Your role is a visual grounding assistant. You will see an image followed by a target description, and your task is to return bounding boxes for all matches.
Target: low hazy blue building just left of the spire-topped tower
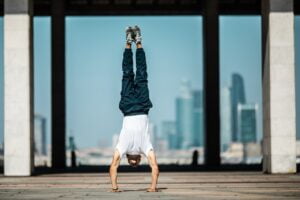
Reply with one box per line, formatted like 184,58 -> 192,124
161,121 -> 178,149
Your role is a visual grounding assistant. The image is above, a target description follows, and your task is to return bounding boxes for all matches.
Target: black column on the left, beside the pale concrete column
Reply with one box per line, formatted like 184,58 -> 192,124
51,0 -> 66,169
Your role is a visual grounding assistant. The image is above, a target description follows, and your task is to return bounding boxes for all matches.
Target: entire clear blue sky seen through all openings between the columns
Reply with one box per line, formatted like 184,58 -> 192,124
0,16 -> 300,147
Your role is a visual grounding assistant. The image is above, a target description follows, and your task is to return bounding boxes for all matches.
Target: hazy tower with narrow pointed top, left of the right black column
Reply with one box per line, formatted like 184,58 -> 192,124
176,80 -> 193,149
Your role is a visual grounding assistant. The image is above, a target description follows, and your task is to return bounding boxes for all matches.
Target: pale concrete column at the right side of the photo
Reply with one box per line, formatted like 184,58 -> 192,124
262,0 -> 296,173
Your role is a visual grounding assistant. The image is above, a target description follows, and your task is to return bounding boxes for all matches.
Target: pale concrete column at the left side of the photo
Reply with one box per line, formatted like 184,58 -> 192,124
4,0 -> 34,176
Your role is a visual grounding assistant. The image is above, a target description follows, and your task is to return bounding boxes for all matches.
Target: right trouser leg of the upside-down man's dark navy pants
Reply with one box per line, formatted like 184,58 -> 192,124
135,43 -> 152,109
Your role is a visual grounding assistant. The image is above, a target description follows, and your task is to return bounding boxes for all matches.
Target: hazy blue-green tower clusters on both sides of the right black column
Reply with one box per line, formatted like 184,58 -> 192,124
160,73 -> 262,152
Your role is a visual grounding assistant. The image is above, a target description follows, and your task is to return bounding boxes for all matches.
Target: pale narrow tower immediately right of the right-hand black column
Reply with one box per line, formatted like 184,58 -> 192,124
220,87 -> 232,152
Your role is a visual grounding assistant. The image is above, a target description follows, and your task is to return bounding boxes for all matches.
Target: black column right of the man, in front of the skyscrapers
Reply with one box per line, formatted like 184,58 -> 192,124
203,0 -> 220,168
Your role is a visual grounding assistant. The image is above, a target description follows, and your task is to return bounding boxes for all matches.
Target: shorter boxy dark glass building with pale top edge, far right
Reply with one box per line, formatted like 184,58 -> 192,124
238,104 -> 258,143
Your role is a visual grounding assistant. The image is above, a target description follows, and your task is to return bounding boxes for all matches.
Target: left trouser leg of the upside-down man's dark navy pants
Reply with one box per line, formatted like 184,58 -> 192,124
119,44 -> 134,111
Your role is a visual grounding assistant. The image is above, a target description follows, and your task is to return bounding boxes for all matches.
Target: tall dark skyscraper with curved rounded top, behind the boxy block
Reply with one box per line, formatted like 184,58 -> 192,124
231,73 -> 246,142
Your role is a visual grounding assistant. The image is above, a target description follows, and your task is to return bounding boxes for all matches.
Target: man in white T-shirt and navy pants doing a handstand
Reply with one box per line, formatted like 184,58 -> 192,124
109,26 -> 159,192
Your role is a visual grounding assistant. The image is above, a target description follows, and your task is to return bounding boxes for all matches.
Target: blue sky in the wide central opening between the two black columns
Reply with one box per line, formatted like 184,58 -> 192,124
66,17 -> 202,148
